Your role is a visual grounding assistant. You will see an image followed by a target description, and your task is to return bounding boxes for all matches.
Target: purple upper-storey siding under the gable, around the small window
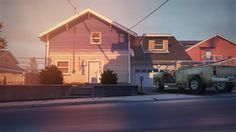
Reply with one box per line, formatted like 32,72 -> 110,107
49,15 -> 128,52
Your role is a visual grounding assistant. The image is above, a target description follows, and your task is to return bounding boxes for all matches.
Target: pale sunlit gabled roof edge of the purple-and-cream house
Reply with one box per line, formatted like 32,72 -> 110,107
39,8 -> 137,38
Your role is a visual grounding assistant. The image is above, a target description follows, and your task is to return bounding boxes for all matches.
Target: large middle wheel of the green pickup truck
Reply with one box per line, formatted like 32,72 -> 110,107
189,77 -> 205,94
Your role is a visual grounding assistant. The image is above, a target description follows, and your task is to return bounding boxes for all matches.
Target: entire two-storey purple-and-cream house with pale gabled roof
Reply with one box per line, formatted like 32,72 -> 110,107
39,9 -> 136,83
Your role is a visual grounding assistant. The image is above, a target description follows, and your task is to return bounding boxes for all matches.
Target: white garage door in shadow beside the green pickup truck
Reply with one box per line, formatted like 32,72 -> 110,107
135,69 -> 158,87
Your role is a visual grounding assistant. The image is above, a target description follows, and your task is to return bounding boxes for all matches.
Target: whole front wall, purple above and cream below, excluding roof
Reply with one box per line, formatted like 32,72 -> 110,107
48,14 -> 129,83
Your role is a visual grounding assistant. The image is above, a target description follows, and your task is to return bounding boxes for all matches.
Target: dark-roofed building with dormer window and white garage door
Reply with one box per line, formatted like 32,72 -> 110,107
131,34 -> 191,87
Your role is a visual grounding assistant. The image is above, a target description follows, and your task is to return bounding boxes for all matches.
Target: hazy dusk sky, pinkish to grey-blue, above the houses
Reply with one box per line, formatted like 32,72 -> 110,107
0,0 -> 236,57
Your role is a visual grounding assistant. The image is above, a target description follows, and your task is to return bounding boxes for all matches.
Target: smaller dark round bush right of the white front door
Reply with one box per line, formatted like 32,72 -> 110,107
100,69 -> 118,84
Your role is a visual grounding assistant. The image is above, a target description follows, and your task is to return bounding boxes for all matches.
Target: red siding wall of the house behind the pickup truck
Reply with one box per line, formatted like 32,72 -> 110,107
186,36 -> 236,61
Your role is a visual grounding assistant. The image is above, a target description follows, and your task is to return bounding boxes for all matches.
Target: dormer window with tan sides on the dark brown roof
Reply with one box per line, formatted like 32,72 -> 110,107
148,39 -> 168,53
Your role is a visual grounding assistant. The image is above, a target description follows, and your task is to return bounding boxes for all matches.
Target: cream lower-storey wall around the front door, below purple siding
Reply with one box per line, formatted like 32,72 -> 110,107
50,52 -> 128,83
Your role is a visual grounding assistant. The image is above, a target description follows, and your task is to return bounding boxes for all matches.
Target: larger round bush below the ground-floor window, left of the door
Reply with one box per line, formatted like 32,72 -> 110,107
39,65 -> 63,84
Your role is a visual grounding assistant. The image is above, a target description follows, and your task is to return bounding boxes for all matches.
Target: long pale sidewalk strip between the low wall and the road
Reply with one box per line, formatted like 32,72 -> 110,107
0,93 -> 236,109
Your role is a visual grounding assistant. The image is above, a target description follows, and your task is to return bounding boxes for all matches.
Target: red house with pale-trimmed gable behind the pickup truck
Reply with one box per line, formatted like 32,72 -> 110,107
186,34 -> 236,63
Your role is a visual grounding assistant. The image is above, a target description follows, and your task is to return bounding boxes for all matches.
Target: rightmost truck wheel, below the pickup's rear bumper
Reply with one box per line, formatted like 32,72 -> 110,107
214,82 -> 233,93
